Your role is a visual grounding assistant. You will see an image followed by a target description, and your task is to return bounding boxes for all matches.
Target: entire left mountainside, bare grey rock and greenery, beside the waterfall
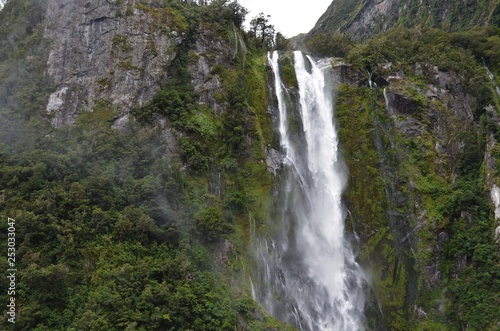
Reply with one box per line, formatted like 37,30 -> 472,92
0,0 -> 291,331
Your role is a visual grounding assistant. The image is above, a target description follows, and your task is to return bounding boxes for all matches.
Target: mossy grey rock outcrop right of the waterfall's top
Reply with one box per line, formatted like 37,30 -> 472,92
332,60 -> 473,169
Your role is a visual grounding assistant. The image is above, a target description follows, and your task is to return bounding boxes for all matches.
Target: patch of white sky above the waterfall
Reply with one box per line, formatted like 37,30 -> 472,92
238,0 -> 332,38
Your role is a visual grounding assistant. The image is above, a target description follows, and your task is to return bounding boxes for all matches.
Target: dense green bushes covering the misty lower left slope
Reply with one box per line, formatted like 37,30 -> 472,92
0,98 -> 284,330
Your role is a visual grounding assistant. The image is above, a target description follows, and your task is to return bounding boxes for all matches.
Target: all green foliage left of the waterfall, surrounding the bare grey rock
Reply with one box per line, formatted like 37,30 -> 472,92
0,1 -> 290,330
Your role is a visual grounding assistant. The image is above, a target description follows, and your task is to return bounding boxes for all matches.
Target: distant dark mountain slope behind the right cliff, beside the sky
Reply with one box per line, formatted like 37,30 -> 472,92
308,0 -> 500,39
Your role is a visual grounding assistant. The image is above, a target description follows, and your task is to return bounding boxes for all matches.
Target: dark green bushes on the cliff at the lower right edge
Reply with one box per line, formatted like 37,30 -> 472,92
432,123 -> 500,330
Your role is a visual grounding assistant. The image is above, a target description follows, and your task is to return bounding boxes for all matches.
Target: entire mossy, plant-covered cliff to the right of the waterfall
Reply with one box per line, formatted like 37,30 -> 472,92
316,24 -> 500,330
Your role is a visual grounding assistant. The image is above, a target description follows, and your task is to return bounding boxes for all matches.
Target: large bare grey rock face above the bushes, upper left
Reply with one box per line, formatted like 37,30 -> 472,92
45,0 -> 182,127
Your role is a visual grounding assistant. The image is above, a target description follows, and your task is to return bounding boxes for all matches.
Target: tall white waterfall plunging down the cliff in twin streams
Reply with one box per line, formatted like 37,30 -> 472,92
256,51 -> 365,331
